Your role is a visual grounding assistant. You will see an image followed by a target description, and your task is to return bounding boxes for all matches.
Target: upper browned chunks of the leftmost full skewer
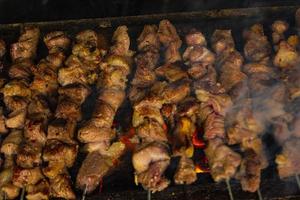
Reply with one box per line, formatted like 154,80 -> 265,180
2,27 -> 40,128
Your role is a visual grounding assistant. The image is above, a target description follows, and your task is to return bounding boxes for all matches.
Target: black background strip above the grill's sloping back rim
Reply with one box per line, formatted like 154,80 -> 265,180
0,0 -> 300,23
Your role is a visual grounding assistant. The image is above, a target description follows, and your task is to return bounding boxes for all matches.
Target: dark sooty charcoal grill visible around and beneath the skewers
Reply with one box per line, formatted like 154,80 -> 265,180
0,6 -> 300,200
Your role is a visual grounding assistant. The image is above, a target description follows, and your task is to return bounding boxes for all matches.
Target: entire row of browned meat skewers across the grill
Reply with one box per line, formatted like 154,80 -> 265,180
0,8 -> 300,199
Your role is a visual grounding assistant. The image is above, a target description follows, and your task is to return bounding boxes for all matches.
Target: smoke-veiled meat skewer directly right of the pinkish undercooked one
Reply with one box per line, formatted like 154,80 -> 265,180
212,27 -> 263,192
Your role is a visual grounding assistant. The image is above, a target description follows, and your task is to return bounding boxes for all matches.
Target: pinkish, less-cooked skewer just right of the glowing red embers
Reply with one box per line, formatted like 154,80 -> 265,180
189,28 -> 241,199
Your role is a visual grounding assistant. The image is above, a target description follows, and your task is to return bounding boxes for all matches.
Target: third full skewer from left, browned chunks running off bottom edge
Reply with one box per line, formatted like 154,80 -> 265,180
43,30 -> 101,199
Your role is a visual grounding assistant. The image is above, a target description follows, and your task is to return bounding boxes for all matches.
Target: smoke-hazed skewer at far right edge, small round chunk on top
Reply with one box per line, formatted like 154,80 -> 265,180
272,16 -> 300,189
